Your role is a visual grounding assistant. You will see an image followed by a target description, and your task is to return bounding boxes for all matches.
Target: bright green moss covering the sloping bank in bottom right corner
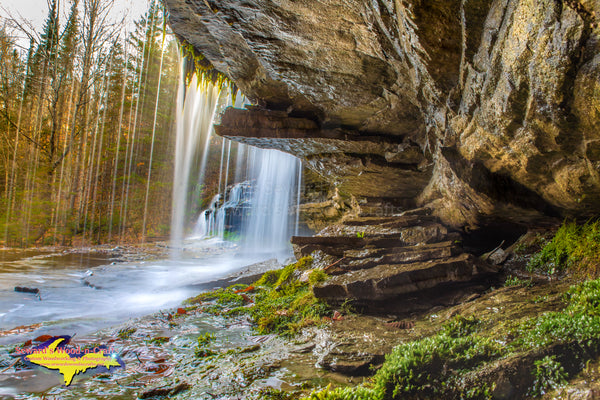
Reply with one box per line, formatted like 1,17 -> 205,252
308,280 -> 600,400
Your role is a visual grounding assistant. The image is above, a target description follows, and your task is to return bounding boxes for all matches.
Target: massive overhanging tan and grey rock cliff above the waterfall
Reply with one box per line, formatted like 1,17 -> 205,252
165,0 -> 600,226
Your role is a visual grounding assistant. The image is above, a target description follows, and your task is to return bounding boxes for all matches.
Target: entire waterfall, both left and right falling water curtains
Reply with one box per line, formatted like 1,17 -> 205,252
171,70 -> 302,258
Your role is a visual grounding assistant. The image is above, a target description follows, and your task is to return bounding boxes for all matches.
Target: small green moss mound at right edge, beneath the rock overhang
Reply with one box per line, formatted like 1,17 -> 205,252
527,221 -> 600,277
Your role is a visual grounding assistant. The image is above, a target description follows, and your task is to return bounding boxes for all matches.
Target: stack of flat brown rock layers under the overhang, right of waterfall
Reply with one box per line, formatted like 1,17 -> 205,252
292,209 -> 498,315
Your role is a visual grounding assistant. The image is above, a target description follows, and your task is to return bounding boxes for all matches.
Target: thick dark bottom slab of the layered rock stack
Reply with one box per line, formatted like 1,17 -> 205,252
313,254 -> 495,303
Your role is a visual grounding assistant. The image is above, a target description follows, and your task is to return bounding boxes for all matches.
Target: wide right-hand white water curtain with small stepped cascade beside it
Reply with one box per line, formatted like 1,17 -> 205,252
193,147 -> 302,259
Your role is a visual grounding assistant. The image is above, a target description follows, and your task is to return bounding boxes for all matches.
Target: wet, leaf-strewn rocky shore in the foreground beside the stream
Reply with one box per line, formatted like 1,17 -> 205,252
0,220 -> 600,399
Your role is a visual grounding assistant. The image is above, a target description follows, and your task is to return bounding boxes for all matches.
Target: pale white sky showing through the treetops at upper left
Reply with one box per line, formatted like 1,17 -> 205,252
0,0 -> 149,49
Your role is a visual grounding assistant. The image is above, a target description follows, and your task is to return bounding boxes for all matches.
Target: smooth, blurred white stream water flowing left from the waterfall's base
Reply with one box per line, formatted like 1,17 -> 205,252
0,247 -> 264,344
